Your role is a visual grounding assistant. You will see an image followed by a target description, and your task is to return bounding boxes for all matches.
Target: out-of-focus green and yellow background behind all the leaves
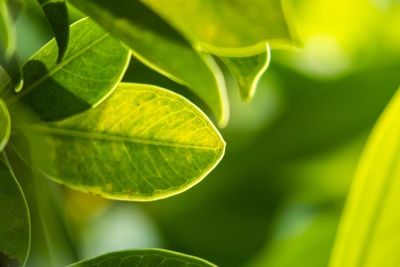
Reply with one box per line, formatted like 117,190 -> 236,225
17,0 -> 400,267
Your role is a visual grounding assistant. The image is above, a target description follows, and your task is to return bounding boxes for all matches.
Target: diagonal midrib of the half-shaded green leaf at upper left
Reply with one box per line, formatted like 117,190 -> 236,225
11,33 -> 109,100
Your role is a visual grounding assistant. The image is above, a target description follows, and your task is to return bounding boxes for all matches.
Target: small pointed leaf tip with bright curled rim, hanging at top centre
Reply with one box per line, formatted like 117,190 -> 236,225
221,43 -> 271,102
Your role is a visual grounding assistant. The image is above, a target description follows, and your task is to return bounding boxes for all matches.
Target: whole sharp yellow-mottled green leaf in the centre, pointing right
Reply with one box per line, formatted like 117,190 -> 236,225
13,83 -> 225,201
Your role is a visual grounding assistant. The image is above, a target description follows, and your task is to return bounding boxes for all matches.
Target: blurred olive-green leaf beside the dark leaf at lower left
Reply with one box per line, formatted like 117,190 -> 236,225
6,147 -> 77,267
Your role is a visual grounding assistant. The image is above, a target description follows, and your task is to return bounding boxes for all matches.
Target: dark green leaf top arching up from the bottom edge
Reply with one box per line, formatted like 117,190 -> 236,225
68,248 -> 216,267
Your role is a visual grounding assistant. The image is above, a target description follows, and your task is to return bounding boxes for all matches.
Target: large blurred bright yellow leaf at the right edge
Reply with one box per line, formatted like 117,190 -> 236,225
329,86 -> 400,267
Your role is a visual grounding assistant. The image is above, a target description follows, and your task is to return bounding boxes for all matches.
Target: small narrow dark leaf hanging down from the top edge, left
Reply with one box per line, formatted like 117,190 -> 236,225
38,0 -> 69,62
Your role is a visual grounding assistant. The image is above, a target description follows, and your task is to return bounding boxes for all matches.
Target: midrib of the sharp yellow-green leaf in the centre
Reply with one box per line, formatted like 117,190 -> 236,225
20,125 -> 223,150
